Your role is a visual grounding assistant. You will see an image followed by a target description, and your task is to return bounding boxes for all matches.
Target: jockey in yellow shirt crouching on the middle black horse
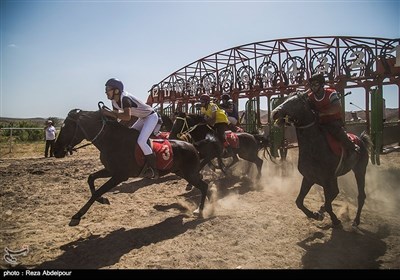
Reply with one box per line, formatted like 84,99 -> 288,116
200,94 -> 229,149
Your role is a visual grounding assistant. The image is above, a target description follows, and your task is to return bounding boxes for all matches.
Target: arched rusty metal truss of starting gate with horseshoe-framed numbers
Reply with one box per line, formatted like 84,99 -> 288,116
147,36 -> 400,125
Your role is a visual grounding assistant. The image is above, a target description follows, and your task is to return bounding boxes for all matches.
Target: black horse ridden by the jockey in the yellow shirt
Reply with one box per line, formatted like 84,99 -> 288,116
169,112 -> 263,179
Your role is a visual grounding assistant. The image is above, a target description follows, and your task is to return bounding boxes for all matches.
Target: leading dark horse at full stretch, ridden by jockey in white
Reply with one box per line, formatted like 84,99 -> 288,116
54,109 -> 208,226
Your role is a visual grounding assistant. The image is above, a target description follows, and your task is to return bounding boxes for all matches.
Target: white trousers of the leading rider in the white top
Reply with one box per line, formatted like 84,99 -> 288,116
131,113 -> 158,156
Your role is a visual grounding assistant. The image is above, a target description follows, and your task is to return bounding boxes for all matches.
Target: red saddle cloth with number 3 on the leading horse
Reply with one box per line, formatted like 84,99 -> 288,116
135,139 -> 174,170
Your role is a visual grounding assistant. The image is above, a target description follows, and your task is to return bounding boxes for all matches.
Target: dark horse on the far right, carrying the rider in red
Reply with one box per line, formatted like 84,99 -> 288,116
272,92 -> 372,226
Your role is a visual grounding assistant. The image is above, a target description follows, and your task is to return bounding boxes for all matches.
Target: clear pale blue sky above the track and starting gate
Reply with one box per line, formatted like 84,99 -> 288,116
0,0 -> 400,118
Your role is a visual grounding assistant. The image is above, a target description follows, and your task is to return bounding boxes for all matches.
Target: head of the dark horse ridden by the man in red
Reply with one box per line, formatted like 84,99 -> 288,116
272,92 -> 315,127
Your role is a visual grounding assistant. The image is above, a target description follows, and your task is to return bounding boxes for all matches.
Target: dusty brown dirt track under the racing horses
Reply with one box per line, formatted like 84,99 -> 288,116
0,147 -> 400,269
